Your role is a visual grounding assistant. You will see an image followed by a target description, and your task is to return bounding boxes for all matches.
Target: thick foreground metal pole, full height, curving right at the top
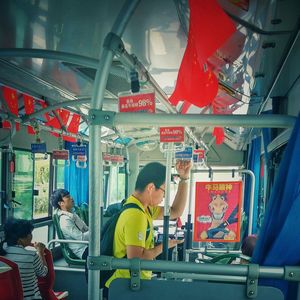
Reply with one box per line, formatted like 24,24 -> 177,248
88,0 -> 139,300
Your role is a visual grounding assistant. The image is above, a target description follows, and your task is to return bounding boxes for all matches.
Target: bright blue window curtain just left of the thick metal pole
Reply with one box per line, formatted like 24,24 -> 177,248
64,142 -> 89,206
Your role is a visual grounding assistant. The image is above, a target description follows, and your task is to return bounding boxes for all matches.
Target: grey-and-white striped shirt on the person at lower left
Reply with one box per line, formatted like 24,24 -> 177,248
4,245 -> 48,300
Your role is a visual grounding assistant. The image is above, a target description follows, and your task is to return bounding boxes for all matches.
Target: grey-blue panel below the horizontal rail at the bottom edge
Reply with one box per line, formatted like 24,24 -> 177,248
109,279 -> 284,300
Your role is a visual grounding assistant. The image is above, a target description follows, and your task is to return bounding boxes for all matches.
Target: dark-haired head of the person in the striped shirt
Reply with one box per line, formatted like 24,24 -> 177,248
4,219 -> 33,247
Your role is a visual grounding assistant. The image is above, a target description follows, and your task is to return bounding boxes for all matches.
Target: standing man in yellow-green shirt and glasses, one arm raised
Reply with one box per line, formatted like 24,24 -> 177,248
105,161 -> 192,288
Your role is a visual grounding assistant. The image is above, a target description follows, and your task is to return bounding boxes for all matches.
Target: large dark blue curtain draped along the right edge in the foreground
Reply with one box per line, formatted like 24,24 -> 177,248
253,115 -> 300,299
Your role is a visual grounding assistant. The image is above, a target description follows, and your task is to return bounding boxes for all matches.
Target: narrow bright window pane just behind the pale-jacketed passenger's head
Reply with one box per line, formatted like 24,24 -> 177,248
33,154 -> 50,219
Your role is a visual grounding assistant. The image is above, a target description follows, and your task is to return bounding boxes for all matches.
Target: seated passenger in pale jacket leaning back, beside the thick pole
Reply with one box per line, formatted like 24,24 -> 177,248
50,189 -> 89,259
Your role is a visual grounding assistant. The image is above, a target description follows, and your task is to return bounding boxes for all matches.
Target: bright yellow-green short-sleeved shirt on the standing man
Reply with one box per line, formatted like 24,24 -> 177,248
105,196 -> 160,287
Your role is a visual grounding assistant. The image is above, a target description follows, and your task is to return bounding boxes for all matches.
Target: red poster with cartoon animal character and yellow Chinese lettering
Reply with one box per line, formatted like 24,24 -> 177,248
194,181 -> 242,242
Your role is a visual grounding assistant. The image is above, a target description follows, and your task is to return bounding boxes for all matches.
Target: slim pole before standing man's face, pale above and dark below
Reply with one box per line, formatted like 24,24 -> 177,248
163,143 -> 173,260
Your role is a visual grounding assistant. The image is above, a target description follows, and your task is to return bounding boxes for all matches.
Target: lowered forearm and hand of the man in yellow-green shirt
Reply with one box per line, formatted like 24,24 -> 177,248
126,240 -> 184,260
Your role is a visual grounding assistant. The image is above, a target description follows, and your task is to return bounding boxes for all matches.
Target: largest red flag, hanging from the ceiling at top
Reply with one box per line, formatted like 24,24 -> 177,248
170,0 -> 235,107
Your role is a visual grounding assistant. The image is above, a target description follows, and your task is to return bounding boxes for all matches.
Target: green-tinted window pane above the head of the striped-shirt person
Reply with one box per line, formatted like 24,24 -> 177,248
13,150 -> 33,220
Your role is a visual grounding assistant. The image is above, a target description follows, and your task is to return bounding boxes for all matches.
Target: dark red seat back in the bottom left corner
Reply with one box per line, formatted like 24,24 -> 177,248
0,256 -> 23,300
